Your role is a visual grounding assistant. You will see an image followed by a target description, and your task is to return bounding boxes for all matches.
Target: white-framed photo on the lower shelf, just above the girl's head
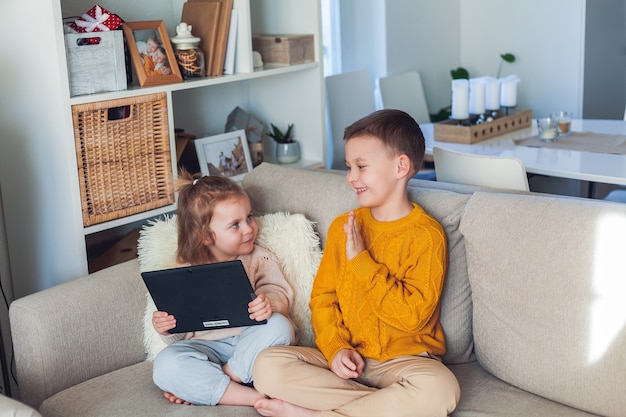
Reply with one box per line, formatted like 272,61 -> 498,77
194,129 -> 252,181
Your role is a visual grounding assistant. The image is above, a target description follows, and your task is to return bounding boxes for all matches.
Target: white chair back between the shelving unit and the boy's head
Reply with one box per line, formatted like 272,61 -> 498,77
325,70 -> 376,169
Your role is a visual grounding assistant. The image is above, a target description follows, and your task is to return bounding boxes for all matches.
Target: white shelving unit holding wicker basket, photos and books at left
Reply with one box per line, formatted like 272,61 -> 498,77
0,0 -> 326,298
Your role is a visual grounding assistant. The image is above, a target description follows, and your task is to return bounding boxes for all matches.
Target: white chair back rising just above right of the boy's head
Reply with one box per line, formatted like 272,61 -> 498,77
378,71 -> 430,124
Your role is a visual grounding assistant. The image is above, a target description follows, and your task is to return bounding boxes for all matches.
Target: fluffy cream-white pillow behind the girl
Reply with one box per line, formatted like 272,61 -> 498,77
137,213 -> 322,360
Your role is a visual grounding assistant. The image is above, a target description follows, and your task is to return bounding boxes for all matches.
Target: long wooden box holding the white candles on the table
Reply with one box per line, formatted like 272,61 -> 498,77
434,110 -> 533,144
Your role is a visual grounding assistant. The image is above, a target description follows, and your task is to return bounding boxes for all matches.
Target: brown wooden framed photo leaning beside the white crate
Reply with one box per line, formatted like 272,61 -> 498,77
122,20 -> 183,87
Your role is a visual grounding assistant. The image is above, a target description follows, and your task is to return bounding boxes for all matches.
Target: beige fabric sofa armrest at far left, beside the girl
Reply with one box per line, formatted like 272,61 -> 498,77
9,260 -> 147,408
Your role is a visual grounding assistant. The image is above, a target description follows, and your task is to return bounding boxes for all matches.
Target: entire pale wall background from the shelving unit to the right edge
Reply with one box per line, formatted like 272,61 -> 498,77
341,0 -> 626,122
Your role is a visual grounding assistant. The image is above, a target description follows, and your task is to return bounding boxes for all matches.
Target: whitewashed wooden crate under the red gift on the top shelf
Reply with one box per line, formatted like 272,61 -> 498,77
65,30 -> 127,96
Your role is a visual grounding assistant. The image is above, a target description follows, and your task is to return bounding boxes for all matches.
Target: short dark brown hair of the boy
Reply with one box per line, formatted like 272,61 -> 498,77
343,109 -> 426,176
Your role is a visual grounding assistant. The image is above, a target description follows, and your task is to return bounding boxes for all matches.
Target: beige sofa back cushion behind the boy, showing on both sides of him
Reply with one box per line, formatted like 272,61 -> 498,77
243,163 -> 474,363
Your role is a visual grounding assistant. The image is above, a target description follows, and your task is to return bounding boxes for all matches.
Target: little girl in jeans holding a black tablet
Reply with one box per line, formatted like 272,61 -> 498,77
152,171 -> 295,406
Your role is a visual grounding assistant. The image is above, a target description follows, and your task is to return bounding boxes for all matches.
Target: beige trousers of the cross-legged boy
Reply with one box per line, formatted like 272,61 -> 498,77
252,346 -> 460,417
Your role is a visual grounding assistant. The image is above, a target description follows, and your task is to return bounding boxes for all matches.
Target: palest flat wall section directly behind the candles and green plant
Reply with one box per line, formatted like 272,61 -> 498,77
460,0 -> 585,117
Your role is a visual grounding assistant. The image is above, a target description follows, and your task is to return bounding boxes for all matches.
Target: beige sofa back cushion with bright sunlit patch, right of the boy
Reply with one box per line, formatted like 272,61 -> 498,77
461,192 -> 626,416
